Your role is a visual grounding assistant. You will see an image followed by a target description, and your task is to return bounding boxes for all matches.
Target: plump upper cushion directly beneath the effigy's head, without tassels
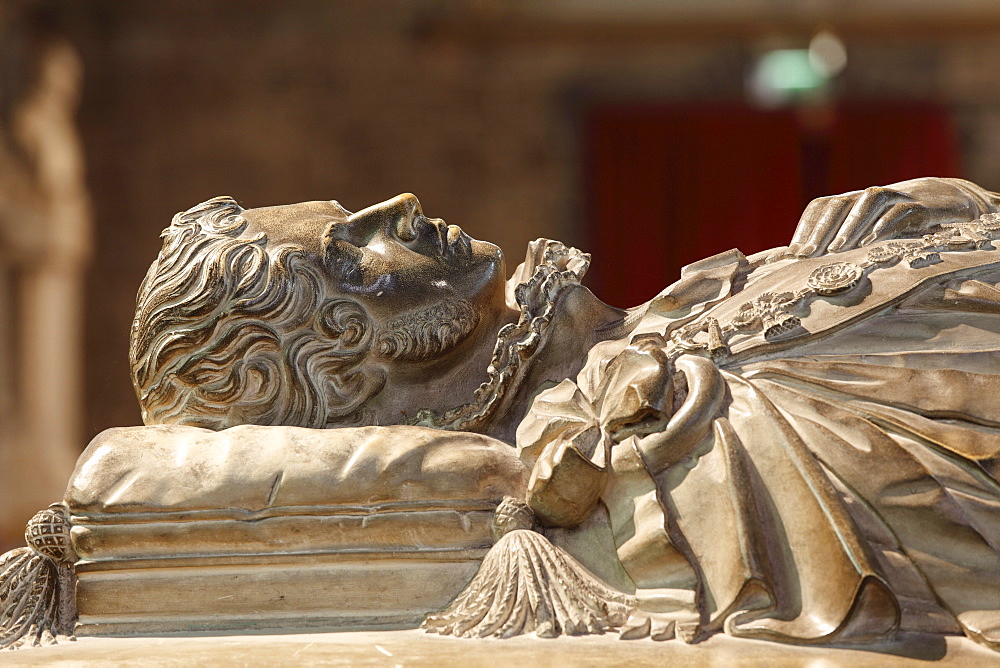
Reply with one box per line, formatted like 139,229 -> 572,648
66,426 -> 528,561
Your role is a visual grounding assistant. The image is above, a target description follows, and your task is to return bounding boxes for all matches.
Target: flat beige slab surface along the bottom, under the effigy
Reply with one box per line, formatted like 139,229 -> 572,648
0,630 -> 1000,668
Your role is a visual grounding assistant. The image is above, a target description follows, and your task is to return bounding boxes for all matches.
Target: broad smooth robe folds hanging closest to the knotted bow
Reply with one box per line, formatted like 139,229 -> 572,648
625,362 -> 900,643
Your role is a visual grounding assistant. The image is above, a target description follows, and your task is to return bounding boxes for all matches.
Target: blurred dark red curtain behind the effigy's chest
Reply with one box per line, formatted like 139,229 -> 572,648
584,102 -> 959,306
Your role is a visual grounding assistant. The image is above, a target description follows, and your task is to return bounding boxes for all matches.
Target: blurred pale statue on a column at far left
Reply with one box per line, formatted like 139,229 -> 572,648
0,14 -> 91,545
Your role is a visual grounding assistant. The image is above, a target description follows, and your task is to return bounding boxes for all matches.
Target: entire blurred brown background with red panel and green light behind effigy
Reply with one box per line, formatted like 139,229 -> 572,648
0,0 -> 1000,547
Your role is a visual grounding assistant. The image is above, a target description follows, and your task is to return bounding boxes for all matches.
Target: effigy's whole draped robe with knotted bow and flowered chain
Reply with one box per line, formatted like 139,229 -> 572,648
518,238 -> 1000,645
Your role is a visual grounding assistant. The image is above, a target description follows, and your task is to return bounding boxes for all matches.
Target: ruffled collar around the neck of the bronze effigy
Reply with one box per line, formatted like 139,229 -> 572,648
412,239 -> 590,431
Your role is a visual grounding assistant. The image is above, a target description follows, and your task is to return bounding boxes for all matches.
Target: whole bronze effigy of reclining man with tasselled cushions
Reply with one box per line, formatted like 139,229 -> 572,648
0,179 -> 1000,649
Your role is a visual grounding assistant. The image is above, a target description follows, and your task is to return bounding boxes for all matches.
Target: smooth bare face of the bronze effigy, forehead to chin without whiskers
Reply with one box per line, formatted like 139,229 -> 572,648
243,194 -> 505,322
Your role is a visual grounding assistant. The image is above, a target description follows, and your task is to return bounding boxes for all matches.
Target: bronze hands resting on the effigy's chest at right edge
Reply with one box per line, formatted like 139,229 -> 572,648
780,177 -> 1000,257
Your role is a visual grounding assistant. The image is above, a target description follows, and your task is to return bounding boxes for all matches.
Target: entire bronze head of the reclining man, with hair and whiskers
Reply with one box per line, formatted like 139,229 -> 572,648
129,195 -> 519,429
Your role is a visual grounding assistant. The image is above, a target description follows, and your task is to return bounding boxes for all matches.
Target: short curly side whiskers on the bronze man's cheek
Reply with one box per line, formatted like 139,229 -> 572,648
377,299 -> 479,361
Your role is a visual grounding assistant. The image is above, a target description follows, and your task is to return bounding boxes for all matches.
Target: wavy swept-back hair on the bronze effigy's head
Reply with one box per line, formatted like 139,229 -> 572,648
129,197 -> 385,429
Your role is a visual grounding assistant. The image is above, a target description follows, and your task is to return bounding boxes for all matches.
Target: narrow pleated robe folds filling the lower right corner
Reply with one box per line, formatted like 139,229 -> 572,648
746,361 -> 1000,645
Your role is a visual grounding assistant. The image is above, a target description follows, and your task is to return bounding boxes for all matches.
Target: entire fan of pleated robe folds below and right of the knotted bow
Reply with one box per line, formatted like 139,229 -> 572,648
605,344 -> 1000,644
